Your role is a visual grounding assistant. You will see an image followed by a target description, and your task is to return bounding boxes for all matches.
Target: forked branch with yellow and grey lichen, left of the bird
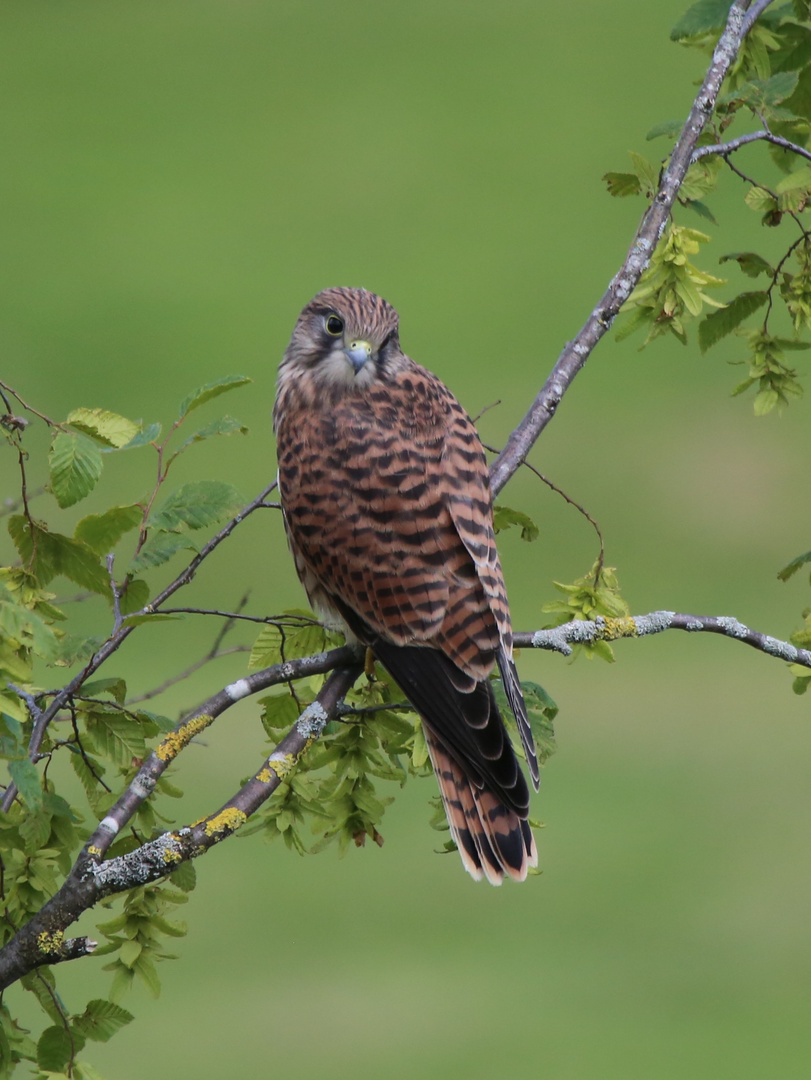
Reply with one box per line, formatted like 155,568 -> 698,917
0,646 -> 363,990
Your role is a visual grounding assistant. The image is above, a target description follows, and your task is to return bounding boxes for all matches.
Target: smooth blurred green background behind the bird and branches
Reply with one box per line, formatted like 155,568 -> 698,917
0,0 -> 811,1080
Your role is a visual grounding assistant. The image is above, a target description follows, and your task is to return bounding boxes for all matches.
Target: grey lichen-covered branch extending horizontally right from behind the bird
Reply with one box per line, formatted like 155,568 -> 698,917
513,611 -> 811,667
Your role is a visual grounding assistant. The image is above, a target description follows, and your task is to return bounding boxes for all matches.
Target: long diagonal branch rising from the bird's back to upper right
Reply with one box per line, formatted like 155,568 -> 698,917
490,0 -> 771,494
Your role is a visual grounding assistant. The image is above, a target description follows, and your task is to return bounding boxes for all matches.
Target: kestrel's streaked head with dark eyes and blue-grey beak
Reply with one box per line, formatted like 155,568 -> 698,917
279,287 -> 403,394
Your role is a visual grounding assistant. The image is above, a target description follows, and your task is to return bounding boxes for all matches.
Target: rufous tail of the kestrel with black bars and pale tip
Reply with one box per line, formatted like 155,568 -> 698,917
422,719 -> 538,885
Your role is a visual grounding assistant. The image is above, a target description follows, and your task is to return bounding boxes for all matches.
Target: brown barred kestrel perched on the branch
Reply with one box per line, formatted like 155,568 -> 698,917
273,286 -> 540,885
